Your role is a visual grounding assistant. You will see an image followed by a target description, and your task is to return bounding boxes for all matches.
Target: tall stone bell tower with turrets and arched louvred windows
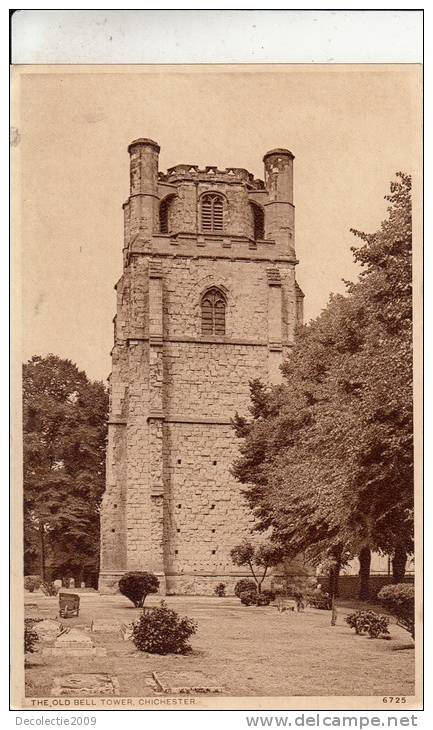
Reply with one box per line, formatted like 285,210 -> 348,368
99,139 -> 303,593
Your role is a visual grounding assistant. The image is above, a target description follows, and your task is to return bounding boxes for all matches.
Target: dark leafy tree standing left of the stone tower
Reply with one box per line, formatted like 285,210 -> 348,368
23,355 -> 108,580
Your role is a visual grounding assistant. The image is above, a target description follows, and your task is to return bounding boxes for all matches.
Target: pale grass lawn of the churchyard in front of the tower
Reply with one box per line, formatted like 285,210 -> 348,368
26,593 -> 415,697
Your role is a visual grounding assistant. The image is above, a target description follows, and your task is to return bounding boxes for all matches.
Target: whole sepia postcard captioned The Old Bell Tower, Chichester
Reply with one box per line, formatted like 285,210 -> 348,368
11,22 -> 423,711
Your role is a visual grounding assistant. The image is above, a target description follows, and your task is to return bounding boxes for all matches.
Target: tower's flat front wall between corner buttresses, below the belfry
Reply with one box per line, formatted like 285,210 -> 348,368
158,258 -> 295,593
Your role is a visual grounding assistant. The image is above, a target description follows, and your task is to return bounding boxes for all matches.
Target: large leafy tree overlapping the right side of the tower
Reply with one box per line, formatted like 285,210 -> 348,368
233,173 -> 413,598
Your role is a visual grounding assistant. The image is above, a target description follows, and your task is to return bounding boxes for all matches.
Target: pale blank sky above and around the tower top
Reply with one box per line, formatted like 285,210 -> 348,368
15,65 -> 421,380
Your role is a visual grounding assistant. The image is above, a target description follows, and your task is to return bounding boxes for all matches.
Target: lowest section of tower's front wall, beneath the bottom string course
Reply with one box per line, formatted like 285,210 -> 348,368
165,423 -> 252,593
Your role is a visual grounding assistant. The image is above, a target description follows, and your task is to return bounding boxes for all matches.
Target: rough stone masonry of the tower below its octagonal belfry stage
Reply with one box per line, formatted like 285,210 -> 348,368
102,256 -> 296,593
